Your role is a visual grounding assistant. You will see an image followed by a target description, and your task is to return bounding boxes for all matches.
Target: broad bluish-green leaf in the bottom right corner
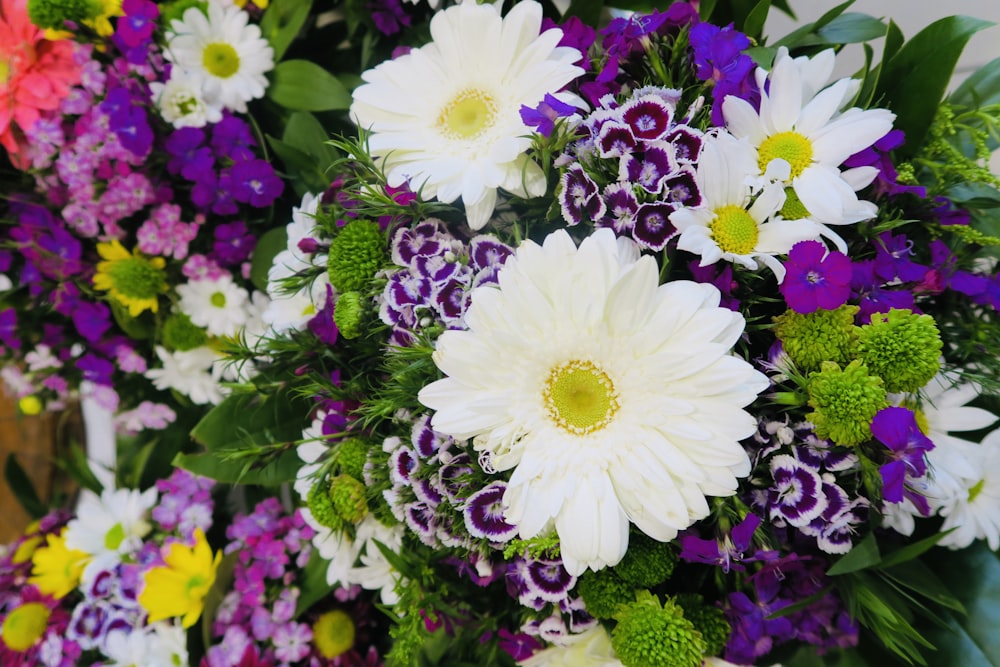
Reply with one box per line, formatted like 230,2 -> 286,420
927,542 -> 1000,667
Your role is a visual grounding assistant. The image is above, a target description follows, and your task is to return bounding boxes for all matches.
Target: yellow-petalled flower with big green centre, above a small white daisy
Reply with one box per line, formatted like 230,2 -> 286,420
94,239 -> 167,317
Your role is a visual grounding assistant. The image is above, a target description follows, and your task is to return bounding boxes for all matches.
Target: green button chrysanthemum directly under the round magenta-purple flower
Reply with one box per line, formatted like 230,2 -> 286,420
774,305 -> 859,372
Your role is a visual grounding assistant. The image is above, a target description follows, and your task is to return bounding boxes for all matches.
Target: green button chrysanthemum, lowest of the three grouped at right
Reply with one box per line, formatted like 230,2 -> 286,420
806,359 -> 889,446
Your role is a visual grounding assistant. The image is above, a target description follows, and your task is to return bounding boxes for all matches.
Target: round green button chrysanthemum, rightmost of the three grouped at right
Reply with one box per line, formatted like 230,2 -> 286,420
858,308 -> 942,392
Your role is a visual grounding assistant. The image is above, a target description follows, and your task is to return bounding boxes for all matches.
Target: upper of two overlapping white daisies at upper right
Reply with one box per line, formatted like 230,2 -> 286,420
722,47 -> 895,240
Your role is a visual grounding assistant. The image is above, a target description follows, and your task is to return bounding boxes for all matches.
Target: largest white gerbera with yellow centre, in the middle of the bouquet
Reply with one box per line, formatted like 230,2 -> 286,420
419,229 -> 768,575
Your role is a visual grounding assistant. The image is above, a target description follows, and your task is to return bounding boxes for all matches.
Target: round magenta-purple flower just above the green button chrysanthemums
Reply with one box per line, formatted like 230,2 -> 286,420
778,241 -> 852,314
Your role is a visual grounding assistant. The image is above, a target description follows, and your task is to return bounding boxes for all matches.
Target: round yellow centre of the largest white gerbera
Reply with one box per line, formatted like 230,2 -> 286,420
542,361 -> 619,435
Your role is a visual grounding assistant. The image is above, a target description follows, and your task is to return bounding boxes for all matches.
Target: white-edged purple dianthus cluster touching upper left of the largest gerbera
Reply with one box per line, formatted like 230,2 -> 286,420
379,220 -> 513,346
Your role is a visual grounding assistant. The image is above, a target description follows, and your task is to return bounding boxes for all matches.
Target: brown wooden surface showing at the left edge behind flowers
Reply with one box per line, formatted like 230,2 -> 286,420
0,392 -> 76,544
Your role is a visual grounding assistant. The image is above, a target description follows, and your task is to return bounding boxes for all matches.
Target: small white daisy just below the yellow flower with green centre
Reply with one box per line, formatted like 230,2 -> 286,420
177,275 -> 250,336
